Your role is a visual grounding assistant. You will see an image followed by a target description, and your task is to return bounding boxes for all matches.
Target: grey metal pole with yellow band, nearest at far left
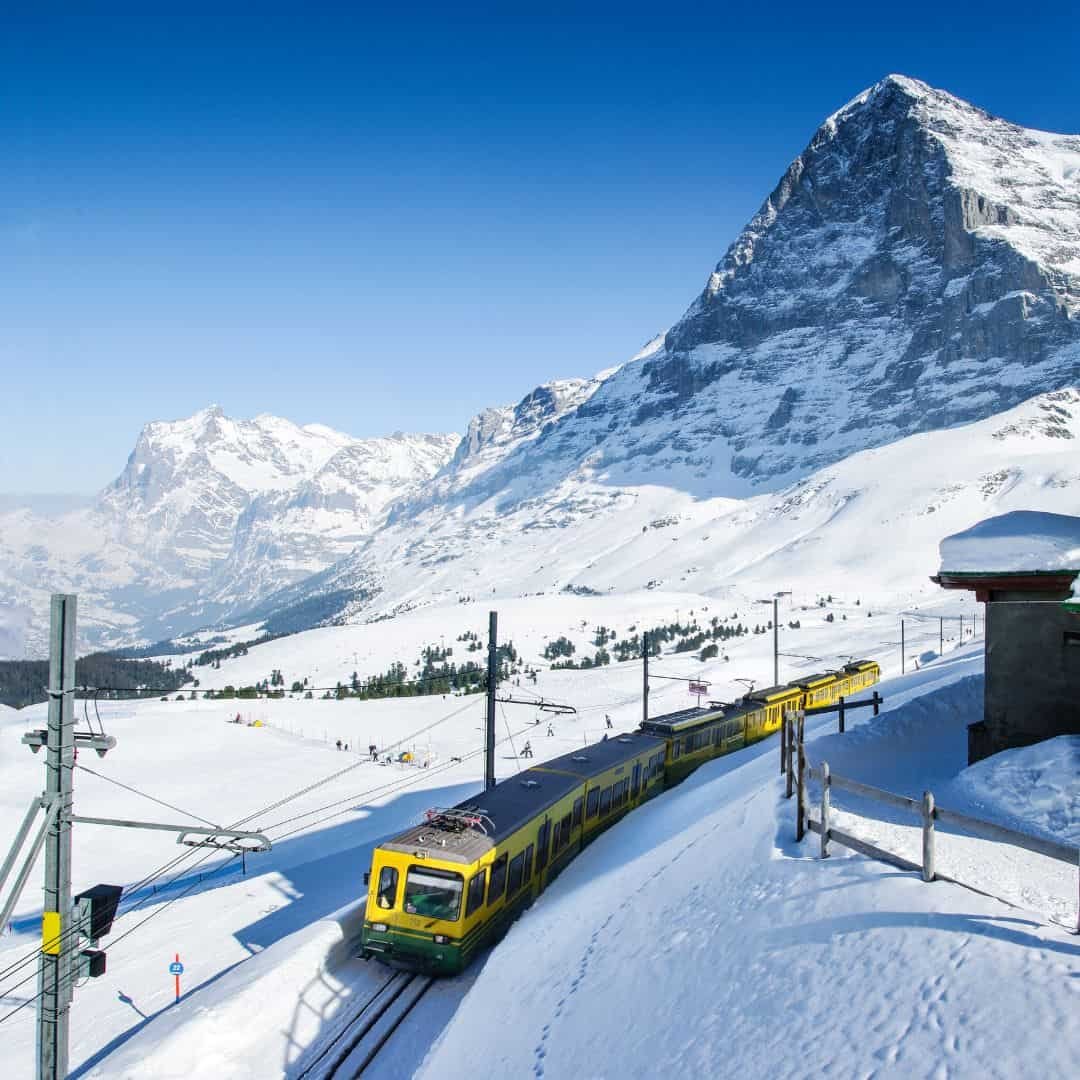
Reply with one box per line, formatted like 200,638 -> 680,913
38,594 -> 77,1080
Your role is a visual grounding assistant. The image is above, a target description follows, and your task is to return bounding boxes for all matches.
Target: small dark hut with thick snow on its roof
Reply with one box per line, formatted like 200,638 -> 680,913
931,511 -> 1080,764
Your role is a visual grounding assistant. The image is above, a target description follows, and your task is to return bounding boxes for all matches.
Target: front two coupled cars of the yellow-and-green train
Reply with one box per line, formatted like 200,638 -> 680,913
361,731 -> 664,974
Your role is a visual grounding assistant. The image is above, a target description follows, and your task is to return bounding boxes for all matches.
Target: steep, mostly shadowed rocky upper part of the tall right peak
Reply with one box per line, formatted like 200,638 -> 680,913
609,76 -> 1080,485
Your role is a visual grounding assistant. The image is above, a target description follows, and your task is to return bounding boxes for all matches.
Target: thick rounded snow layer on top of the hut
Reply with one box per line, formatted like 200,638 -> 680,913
940,510 -> 1080,576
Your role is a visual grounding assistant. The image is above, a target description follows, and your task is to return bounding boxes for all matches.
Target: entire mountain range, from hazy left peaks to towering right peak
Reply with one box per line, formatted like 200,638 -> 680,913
0,76 -> 1080,652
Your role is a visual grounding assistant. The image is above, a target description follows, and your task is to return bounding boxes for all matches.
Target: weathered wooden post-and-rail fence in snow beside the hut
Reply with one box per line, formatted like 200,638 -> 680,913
781,711 -> 1080,934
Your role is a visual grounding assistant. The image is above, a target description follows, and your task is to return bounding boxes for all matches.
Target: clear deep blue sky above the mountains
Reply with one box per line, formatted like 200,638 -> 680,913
6,2 -> 1080,492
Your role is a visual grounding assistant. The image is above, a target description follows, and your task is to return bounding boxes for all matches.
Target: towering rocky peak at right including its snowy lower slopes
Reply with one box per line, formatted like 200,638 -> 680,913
254,76 -> 1080,630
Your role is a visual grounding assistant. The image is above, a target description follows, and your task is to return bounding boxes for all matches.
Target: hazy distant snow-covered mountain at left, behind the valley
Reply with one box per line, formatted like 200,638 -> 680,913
0,406 -> 460,656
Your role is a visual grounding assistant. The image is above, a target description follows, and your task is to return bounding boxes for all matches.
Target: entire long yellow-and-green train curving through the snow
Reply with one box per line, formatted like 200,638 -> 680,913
361,660 -> 880,974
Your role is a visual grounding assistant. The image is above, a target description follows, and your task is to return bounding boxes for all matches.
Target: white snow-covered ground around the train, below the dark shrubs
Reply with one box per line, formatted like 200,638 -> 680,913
0,622 -> 1080,1078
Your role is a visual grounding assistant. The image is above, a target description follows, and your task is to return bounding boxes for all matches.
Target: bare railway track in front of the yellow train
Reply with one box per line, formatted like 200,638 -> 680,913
297,971 -> 434,1080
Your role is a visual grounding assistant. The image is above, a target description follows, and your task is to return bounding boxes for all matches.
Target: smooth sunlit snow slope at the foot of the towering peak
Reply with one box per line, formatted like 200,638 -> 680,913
267,389 -> 1080,620
